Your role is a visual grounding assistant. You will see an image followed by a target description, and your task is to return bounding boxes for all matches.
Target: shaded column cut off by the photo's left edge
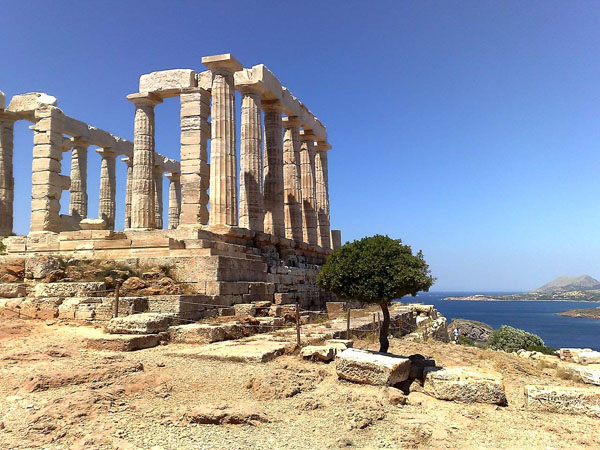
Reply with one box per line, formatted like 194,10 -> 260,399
0,111 -> 16,236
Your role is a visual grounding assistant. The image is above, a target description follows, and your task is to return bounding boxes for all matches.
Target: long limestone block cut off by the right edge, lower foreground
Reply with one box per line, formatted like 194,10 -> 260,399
525,385 -> 600,418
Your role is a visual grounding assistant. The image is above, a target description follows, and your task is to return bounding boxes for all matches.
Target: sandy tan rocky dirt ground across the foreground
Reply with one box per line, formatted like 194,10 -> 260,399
0,319 -> 600,449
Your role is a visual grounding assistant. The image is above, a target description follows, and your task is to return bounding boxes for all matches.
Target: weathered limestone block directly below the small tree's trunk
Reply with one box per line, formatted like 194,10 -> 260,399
335,348 -> 410,386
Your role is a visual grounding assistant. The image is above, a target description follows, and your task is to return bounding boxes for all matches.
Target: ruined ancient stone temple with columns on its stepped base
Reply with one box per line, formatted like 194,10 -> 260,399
0,54 -> 341,307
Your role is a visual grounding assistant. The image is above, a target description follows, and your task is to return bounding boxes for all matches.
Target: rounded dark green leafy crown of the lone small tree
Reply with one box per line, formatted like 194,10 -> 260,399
317,235 -> 435,303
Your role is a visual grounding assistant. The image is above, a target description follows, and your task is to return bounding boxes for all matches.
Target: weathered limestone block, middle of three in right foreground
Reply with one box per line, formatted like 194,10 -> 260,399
423,367 -> 506,405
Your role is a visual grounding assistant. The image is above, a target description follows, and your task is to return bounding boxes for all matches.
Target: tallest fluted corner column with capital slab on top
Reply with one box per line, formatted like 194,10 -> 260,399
202,54 -> 242,226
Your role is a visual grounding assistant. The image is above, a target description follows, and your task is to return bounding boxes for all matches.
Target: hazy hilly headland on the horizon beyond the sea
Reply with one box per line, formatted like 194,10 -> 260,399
444,275 -> 600,300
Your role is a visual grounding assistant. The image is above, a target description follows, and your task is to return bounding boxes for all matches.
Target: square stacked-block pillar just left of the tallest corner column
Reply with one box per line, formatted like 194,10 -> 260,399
179,88 -> 210,228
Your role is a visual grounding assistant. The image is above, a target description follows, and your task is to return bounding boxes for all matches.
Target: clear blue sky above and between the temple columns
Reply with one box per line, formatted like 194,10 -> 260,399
0,0 -> 600,290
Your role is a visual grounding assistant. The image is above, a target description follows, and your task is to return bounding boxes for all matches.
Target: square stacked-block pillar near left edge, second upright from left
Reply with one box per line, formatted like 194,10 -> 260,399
30,105 -> 70,233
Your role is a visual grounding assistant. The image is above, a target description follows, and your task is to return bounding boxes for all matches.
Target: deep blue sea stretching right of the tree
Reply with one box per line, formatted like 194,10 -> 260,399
400,292 -> 600,351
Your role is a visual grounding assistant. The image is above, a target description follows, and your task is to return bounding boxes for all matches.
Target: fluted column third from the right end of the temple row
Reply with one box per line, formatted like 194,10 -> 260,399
283,116 -> 302,242
